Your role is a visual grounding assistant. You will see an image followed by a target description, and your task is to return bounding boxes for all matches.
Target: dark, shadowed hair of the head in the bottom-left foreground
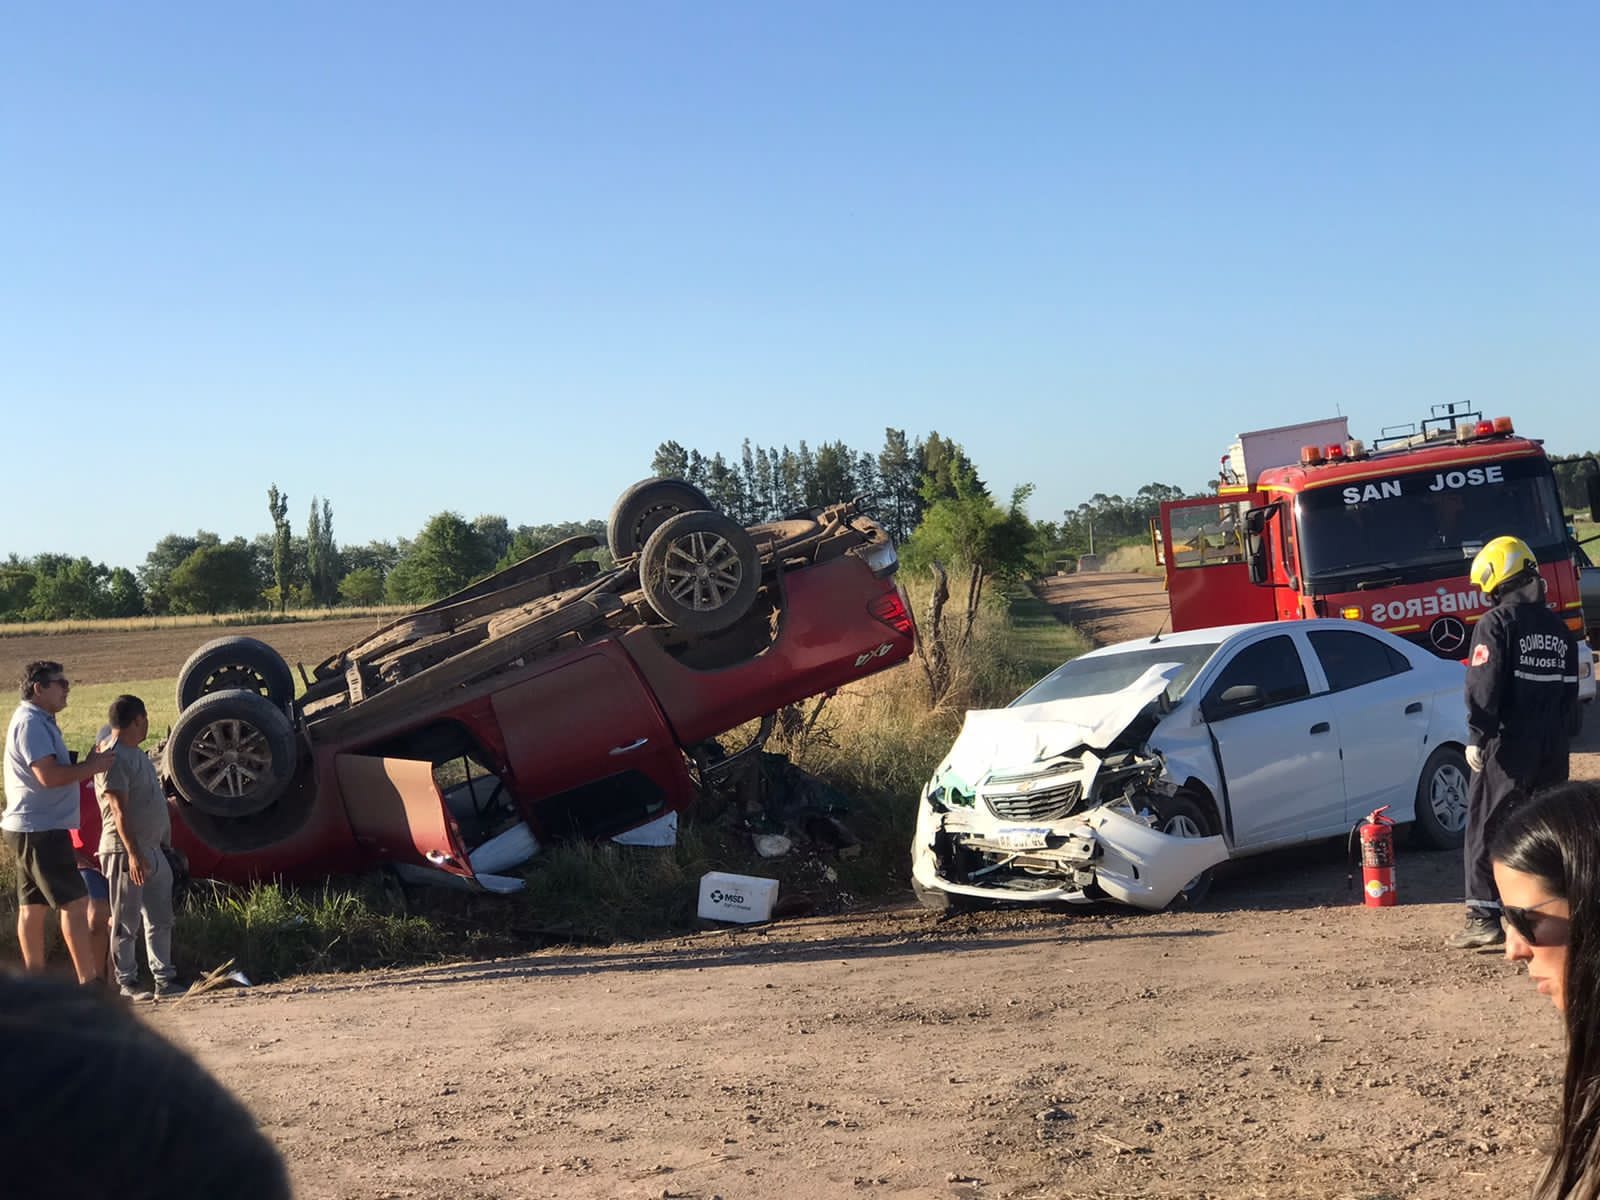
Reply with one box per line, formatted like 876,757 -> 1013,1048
0,973 -> 291,1200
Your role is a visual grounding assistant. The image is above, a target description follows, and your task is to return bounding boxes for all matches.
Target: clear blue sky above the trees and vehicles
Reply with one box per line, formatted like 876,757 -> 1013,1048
0,0 -> 1600,566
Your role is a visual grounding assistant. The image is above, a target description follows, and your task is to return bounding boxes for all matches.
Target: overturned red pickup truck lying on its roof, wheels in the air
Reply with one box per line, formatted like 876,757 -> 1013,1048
162,480 -> 915,882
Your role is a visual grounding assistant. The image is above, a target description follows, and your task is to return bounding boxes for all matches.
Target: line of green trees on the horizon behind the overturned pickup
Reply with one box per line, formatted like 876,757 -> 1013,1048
0,429 -> 1203,622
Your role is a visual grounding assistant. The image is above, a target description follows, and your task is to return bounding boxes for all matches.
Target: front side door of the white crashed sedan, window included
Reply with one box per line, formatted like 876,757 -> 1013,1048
1200,634 -> 1344,850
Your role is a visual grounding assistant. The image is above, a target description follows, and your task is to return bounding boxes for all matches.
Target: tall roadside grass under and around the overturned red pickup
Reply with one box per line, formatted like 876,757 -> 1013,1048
0,579 -> 1090,979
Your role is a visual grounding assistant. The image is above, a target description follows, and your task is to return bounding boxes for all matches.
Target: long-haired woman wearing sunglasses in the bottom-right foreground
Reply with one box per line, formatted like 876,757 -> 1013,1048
1490,782 -> 1600,1200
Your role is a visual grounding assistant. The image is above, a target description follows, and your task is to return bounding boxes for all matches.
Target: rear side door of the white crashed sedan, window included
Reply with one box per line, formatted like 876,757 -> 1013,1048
1306,629 -> 1434,826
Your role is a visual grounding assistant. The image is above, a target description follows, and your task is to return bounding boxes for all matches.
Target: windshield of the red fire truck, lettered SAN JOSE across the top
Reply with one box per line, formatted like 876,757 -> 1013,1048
1294,456 -> 1566,592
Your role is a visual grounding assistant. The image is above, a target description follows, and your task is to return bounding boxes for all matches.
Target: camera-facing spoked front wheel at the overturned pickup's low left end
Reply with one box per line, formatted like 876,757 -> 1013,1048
165,691 -> 298,818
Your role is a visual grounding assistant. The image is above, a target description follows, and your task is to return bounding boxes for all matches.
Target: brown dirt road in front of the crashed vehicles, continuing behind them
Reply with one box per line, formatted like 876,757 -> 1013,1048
152,578 -> 1600,1200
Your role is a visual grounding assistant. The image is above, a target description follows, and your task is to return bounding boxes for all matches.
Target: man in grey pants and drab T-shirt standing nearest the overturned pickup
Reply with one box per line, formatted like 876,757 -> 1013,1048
94,696 -> 182,1000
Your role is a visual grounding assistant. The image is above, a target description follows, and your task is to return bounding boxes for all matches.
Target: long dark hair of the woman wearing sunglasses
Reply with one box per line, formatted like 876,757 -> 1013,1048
1490,782 -> 1600,1200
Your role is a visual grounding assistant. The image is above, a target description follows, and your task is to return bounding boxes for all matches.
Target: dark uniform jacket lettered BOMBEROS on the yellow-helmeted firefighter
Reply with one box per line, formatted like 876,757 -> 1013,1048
1467,586 -> 1578,790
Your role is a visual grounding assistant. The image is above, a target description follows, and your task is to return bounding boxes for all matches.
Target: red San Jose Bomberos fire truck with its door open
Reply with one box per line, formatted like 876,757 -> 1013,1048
1154,405 -> 1600,658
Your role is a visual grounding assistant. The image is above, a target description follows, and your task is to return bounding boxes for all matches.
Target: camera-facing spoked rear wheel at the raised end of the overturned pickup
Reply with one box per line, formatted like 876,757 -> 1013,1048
638,512 -> 762,634
